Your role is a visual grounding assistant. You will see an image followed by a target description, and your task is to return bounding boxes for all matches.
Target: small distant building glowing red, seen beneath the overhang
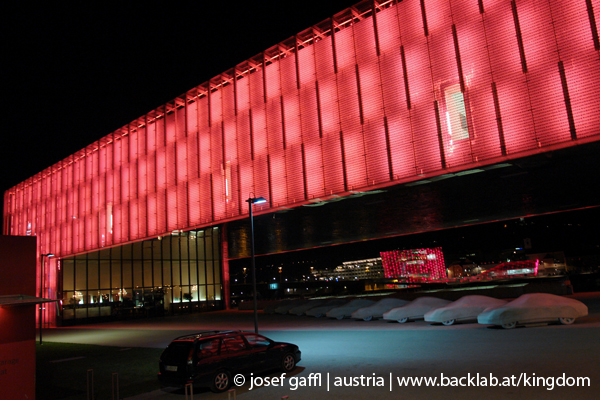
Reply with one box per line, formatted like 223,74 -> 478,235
381,247 -> 448,283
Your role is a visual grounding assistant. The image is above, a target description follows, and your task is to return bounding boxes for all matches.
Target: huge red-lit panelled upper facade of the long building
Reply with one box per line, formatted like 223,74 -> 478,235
4,0 -> 600,324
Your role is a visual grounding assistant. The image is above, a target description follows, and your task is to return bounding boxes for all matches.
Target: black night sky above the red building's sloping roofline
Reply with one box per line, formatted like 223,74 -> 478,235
0,0 -> 356,203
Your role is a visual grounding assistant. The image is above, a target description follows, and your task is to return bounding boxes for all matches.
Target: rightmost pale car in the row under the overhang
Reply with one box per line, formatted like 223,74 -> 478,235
477,293 -> 588,329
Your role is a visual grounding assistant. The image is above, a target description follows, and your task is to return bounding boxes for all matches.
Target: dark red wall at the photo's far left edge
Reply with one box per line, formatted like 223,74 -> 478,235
0,236 -> 36,400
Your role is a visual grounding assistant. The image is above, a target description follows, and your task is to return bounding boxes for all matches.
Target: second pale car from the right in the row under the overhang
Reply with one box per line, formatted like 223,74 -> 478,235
424,295 -> 507,325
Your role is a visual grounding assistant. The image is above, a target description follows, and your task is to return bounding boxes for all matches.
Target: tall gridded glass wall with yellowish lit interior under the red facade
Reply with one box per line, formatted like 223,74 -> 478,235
61,228 -> 221,321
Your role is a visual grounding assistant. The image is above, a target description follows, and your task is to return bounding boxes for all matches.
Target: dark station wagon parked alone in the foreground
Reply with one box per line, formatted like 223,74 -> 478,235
158,331 -> 301,393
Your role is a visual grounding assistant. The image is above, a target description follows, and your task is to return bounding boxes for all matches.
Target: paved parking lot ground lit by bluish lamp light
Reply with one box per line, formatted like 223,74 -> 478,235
44,293 -> 600,400
